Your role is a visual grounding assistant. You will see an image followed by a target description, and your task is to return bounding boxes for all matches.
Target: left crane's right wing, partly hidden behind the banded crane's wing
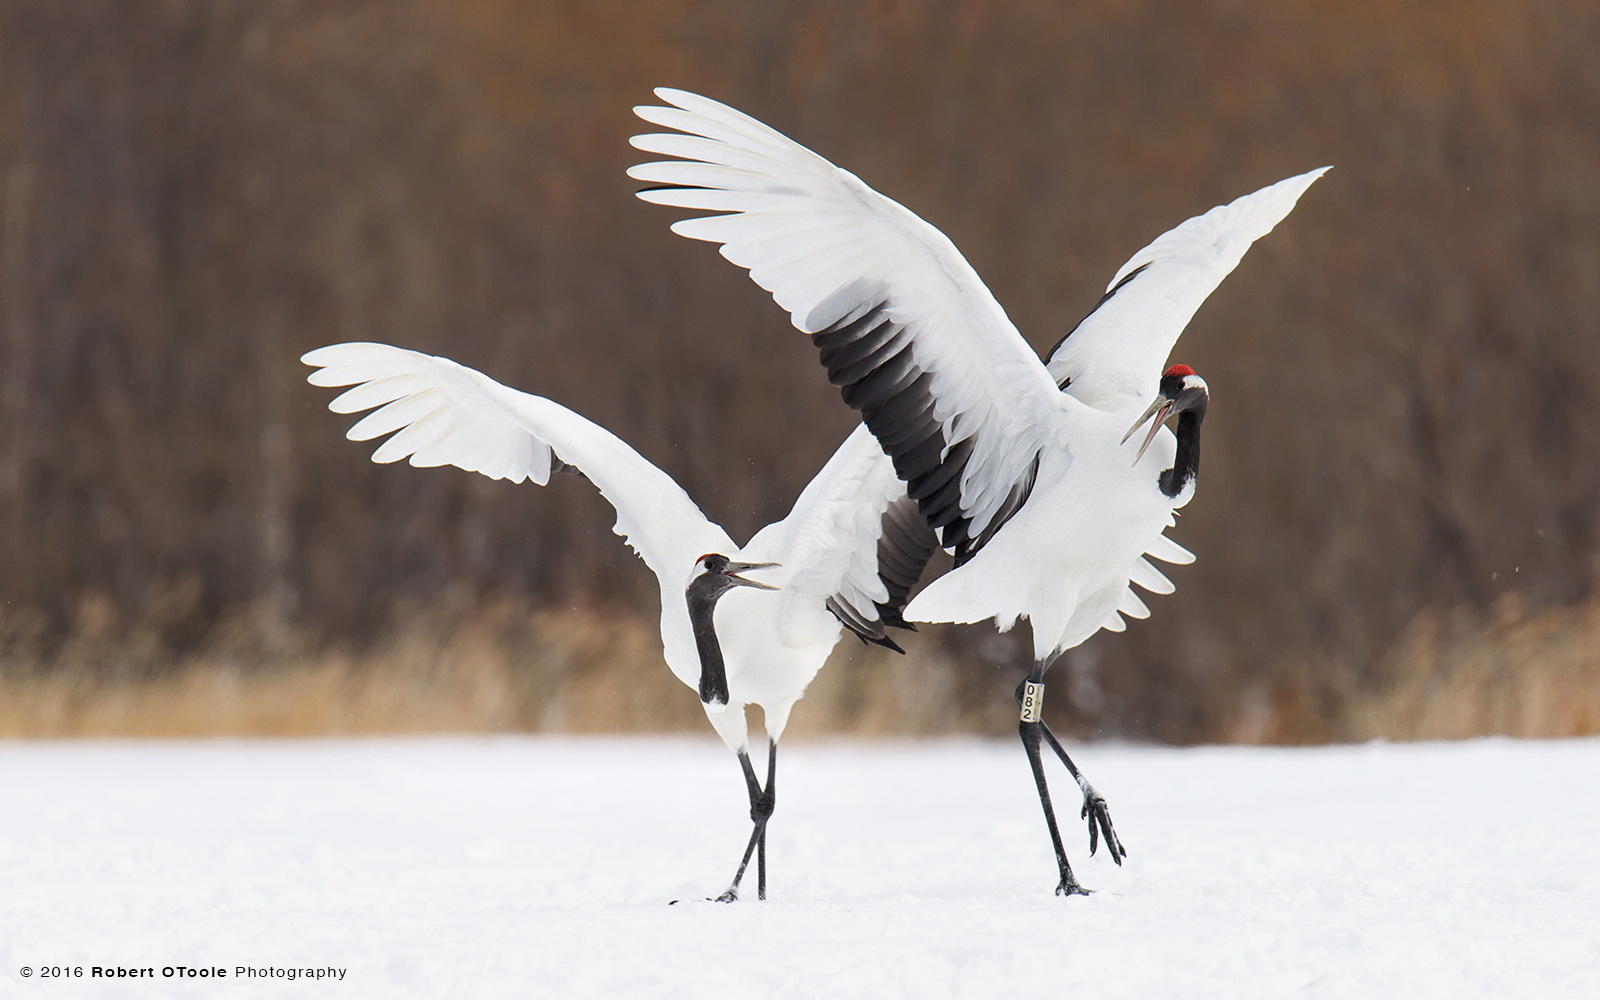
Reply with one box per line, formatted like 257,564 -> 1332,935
744,426 -> 938,651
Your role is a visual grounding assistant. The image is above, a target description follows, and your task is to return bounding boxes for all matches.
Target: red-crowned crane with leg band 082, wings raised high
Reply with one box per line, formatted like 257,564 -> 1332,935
627,88 -> 1326,894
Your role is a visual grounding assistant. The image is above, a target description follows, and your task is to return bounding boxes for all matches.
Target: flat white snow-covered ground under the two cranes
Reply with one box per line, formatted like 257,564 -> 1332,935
0,738 -> 1600,1000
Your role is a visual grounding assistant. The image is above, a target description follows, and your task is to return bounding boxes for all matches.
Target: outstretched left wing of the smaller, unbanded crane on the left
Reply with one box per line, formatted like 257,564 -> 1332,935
301,344 -> 736,584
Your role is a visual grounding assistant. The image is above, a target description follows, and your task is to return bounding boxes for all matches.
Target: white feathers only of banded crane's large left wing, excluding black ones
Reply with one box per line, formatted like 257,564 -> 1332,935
627,88 -> 1066,550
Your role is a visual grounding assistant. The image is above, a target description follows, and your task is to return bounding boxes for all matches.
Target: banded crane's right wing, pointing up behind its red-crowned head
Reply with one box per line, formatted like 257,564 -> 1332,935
1045,166 -> 1328,408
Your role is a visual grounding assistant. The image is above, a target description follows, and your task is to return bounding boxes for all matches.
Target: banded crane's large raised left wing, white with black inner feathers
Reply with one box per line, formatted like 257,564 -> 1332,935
627,88 -> 1075,563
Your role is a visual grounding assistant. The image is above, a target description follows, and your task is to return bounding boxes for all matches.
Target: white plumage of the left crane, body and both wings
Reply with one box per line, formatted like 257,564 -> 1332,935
301,344 -> 906,752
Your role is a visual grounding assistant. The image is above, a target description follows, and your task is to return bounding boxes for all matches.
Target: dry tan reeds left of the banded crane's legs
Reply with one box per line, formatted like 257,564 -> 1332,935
0,594 -> 1006,738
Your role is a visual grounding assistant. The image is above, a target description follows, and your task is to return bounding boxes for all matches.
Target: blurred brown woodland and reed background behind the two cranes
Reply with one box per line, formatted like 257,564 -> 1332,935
0,0 -> 1600,741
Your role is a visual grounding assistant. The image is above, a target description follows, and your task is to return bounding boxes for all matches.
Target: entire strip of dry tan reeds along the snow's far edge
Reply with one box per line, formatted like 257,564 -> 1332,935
0,592 -> 1600,744
